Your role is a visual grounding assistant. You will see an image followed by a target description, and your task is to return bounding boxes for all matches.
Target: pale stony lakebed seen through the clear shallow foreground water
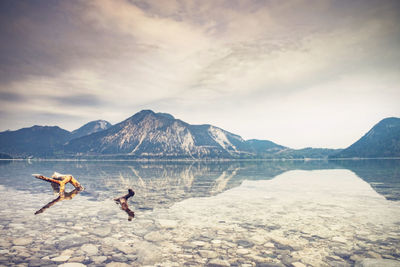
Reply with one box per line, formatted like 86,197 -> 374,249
0,170 -> 400,267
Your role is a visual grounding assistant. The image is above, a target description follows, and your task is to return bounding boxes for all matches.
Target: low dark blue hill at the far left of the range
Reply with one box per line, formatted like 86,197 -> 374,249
0,125 -> 70,157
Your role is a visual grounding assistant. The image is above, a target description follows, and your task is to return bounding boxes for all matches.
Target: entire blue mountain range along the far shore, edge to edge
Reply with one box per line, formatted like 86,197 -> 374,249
0,110 -> 400,159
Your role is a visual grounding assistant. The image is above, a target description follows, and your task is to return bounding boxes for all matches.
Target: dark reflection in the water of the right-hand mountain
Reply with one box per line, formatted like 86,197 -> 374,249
337,160 -> 400,200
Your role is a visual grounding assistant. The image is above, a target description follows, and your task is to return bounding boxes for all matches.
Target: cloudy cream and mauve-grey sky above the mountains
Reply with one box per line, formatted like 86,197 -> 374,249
0,0 -> 400,148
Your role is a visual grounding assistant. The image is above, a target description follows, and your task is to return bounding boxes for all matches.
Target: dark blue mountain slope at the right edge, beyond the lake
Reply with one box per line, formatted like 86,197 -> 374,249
332,117 -> 400,158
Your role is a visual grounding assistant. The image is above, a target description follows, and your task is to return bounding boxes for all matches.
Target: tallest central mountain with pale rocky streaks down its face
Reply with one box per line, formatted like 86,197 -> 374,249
64,110 -> 283,158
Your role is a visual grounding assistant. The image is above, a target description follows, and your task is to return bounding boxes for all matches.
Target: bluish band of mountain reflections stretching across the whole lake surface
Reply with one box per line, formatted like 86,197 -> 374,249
0,160 -> 400,209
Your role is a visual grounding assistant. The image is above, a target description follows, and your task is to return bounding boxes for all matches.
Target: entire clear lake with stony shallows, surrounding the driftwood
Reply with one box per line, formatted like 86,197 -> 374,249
0,160 -> 400,267
